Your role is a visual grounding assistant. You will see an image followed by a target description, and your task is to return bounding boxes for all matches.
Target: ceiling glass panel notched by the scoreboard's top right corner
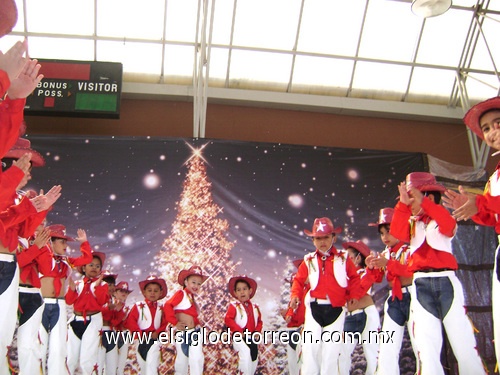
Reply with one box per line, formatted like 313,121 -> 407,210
97,41 -> 161,76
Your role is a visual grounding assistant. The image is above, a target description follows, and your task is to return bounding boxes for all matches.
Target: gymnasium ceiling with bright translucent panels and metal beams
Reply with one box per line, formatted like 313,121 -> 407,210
0,0 -> 500,126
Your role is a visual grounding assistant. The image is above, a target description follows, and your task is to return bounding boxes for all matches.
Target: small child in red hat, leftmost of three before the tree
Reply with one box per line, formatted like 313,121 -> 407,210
125,275 -> 167,375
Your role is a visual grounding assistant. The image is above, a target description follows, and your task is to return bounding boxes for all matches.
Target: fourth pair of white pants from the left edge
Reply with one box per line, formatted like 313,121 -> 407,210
67,313 -> 102,375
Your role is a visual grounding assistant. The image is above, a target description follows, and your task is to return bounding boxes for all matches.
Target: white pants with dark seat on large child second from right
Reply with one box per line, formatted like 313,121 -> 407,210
410,271 -> 485,375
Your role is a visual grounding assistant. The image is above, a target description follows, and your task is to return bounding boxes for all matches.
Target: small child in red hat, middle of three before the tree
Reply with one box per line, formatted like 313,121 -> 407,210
164,266 -> 208,375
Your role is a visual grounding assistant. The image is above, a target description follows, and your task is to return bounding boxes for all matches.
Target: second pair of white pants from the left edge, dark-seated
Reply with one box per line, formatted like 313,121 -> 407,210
17,286 -> 43,375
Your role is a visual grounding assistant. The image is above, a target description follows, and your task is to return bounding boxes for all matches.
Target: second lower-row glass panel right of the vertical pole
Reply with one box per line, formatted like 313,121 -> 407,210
229,50 -> 292,86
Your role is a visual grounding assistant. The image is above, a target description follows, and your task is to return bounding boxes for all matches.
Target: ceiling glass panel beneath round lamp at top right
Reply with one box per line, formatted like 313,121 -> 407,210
416,9 -> 472,66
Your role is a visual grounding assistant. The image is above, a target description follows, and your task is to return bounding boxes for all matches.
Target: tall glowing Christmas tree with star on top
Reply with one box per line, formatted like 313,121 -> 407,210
156,146 -> 237,374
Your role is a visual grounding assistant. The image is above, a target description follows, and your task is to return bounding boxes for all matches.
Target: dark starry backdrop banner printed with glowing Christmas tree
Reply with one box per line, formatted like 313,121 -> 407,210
21,136 -> 490,374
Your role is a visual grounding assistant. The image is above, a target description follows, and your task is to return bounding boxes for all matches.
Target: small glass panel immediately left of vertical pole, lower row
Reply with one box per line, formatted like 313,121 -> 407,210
164,45 -> 195,82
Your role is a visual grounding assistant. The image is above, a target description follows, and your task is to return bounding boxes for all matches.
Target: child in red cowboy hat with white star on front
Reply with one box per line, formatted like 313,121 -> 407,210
289,217 -> 366,375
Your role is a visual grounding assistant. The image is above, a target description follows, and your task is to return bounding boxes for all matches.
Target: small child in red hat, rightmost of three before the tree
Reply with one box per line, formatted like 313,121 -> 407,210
224,276 -> 262,375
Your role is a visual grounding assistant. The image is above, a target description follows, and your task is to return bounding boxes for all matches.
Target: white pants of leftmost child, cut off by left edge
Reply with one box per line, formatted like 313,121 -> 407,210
0,253 -> 19,375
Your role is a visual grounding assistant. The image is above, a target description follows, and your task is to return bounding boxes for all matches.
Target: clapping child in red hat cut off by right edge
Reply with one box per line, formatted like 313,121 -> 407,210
443,96 -> 500,368
